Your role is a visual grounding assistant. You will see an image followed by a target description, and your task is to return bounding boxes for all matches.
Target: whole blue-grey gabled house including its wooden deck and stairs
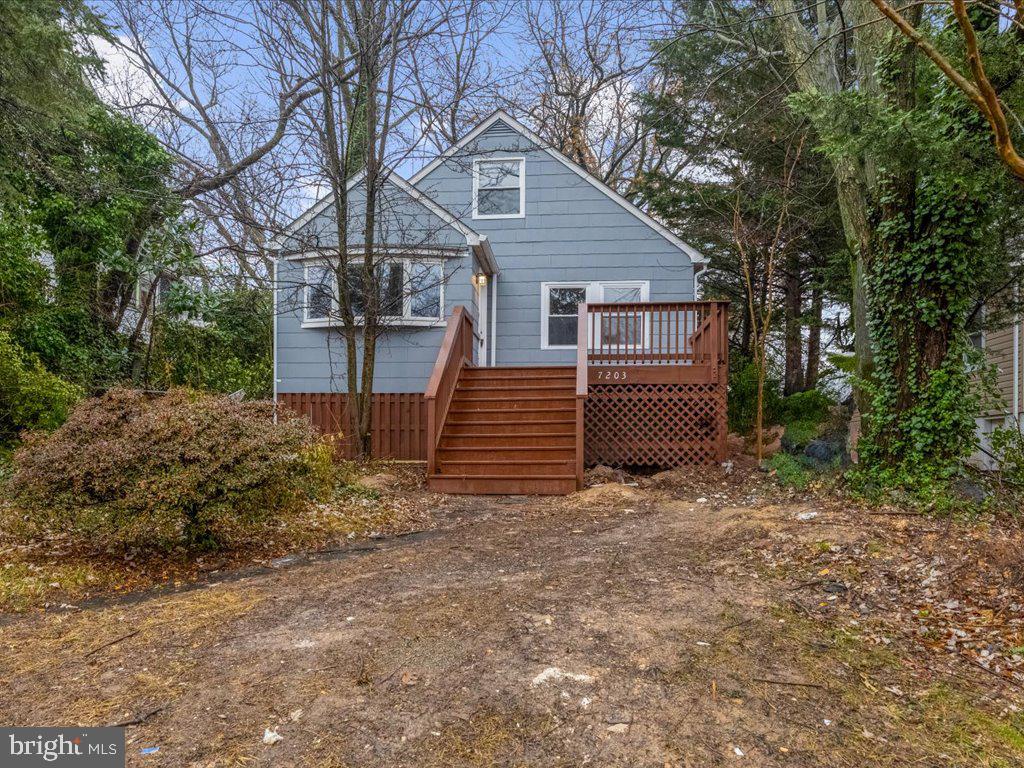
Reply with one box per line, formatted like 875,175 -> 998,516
274,111 -> 727,493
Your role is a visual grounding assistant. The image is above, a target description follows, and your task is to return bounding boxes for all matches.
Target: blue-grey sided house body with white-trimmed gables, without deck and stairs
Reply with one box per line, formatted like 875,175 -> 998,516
274,111 -> 720,493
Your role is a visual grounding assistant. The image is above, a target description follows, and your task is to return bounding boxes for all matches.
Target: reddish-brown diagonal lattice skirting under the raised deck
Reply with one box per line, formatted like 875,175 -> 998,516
584,383 -> 728,469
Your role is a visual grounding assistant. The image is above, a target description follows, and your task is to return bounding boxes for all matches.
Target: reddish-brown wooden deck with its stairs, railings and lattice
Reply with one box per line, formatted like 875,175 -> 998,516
424,301 -> 728,494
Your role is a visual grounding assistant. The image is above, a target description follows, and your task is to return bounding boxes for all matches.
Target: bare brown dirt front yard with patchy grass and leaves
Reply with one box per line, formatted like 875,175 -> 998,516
0,470 -> 1024,768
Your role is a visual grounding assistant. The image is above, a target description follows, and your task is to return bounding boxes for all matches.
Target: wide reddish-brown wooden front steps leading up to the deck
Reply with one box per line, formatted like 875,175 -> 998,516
428,366 -> 577,494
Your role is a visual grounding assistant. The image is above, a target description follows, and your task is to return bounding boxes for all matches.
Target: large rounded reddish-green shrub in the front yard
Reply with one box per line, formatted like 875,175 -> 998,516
8,389 -> 331,549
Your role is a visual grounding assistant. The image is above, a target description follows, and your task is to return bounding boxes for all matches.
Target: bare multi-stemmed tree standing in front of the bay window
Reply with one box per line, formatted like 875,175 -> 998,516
268,0 -> 483,455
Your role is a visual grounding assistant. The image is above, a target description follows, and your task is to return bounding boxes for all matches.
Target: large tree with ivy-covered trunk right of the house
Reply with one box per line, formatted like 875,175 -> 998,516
796,5 -> 1024,490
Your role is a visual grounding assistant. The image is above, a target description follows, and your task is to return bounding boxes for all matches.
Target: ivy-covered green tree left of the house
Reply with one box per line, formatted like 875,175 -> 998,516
28,104 -> 190,386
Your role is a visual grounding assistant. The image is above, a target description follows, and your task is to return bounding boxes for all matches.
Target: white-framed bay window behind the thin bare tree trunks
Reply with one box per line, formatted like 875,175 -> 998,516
303,259 -> 444,326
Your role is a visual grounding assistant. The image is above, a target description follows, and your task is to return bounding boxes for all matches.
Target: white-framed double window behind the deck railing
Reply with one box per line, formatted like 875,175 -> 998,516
541,281 -> 649,349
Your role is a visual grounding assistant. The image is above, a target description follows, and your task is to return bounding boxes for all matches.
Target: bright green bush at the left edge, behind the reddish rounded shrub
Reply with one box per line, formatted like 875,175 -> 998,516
0,331 -> 82,445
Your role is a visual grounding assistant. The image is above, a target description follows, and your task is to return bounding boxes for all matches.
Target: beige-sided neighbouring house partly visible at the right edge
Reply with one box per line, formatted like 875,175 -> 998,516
971,316 -> 1024,469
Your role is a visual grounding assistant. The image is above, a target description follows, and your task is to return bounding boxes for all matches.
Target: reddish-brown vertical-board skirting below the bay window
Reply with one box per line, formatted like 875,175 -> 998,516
278,392 -> 427,461
